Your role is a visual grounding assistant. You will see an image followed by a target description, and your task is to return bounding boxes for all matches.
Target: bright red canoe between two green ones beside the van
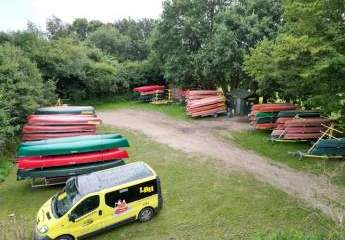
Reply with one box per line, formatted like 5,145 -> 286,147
16,149 -> 128,169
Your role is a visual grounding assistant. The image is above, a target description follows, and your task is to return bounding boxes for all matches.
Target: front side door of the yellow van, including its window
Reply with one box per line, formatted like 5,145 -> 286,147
69,195 -> 102,237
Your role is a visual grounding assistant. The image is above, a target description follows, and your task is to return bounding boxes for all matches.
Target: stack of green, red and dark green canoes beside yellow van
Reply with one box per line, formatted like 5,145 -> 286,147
16,134 -> 129,180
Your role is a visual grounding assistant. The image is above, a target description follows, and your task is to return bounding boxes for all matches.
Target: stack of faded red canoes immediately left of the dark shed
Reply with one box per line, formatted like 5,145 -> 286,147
186,90 -> 226,117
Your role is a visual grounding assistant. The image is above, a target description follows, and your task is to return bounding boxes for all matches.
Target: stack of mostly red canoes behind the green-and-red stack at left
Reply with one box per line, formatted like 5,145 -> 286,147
22,106 -> 102,141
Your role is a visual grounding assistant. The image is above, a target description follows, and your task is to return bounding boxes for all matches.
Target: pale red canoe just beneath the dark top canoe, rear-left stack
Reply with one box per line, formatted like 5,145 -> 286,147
27,114 -> 102,125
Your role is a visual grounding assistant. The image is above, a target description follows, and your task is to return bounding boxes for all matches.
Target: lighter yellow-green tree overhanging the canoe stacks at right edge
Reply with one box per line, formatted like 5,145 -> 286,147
245,0 -> 345,113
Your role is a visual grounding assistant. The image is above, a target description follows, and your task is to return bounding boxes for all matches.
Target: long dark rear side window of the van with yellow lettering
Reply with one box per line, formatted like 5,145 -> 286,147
105,179 -> 157,208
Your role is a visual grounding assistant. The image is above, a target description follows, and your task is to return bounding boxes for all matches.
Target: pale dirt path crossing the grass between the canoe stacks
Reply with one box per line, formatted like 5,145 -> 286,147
99,110 -> 345,220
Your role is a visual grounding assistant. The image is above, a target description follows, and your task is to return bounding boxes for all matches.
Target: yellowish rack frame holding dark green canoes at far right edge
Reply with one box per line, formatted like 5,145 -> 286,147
289,123 -> 345,160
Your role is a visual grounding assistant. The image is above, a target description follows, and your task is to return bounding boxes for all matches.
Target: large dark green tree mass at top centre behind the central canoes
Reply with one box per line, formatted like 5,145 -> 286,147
152,0 -> 281,91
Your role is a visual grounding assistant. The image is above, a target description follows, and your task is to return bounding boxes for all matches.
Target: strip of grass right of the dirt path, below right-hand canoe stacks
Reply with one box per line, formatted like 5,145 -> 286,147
228,131 -> 345,185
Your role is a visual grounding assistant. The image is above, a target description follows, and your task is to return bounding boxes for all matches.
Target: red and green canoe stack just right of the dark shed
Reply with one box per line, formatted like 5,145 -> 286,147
248,103 -> 297,130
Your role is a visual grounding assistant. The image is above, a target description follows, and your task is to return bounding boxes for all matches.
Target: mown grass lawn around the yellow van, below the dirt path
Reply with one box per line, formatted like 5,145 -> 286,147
0,127 -> 335,240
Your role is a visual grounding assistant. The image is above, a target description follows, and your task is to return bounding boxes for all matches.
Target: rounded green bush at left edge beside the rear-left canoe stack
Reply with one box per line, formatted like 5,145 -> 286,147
0,44 -> 55,146
